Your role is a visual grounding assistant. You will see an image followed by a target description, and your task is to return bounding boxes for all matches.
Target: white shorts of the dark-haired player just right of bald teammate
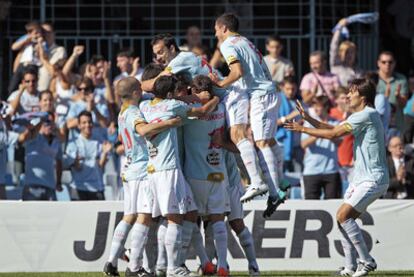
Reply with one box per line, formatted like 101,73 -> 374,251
148,169 -> 197,217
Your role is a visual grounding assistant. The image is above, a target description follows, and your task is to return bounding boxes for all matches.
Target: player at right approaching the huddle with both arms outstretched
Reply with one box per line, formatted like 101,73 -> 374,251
285,79 -> 389,277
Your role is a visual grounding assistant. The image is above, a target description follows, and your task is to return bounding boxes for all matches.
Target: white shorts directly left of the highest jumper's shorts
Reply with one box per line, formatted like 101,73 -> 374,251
223,87 -> 250,127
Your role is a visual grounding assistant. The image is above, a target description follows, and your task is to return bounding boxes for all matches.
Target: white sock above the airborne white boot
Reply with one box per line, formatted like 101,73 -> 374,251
237,139 -> 263,185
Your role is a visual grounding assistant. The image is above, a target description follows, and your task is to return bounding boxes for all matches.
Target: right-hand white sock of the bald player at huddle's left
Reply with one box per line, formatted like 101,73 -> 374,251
128,223 -> 149,271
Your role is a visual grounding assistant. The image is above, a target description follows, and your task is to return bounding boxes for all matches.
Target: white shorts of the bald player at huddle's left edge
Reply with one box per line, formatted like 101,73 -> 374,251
123,180 -> 154,215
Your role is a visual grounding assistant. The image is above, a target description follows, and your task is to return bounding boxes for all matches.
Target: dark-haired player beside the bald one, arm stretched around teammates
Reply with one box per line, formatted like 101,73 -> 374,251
138,76 -> 219,277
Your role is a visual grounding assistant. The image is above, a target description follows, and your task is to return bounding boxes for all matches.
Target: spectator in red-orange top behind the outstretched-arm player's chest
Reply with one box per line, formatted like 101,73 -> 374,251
329,87 -> 354,182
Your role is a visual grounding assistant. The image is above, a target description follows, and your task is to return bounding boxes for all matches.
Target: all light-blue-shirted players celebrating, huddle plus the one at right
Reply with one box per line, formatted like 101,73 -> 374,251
104,13 -> 388,277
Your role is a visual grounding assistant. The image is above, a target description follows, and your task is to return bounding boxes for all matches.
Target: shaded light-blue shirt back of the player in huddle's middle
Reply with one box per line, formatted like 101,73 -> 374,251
183,104 -> 226,181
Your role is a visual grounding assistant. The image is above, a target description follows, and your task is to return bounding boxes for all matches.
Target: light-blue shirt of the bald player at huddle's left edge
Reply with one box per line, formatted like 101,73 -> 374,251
118,105 -> 148,181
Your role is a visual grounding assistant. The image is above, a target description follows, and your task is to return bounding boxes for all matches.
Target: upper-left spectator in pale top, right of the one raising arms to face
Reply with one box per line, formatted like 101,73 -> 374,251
37,23 -> 67,91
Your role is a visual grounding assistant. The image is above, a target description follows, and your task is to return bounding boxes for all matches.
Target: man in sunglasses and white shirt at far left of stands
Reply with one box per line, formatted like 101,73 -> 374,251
7,68 -> 39,114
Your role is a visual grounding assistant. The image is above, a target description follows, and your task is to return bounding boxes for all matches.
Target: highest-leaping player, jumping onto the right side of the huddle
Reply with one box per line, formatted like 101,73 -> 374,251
211,13 -> 286,217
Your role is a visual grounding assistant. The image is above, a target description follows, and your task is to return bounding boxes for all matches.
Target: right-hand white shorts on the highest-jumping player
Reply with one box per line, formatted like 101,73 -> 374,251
250,92 -> 280,141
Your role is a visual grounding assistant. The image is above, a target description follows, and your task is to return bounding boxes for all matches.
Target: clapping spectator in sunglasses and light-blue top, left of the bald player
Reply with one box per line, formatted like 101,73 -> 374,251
66,78 -> 109,140
